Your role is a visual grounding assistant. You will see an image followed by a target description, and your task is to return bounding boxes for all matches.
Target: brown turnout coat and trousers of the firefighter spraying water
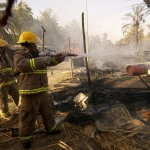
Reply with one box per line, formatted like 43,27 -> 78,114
14,49 -> 64,141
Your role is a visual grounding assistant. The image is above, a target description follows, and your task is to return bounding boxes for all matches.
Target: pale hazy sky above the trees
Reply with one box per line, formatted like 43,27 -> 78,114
13,0 -> 150,42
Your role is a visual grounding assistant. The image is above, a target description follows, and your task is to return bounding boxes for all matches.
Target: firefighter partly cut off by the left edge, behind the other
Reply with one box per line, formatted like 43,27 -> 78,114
0,38 -> 19,120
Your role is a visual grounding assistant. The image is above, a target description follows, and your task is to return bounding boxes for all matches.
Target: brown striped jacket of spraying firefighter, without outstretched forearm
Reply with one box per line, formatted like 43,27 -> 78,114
14,50 -> 48,95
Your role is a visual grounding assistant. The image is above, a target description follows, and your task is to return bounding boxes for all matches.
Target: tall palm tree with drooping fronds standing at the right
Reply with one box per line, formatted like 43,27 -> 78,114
122,5 -> 148,48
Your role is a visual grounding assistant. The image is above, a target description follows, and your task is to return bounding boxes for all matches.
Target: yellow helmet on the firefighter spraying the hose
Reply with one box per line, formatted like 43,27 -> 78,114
17,31 -> 39,44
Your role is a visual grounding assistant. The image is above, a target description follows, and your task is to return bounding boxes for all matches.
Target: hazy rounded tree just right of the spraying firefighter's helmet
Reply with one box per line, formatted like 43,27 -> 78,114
31,9 -> 64,46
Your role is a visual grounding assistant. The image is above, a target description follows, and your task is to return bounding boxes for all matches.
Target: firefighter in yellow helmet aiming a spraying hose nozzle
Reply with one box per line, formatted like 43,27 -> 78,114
14,31 -> 68,149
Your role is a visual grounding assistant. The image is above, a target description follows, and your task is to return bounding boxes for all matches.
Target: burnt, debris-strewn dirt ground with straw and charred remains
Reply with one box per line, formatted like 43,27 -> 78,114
0,62 -> 150,150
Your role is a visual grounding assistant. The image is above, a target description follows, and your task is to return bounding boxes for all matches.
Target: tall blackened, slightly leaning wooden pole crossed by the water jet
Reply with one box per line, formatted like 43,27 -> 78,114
82,13 -> 91,87
